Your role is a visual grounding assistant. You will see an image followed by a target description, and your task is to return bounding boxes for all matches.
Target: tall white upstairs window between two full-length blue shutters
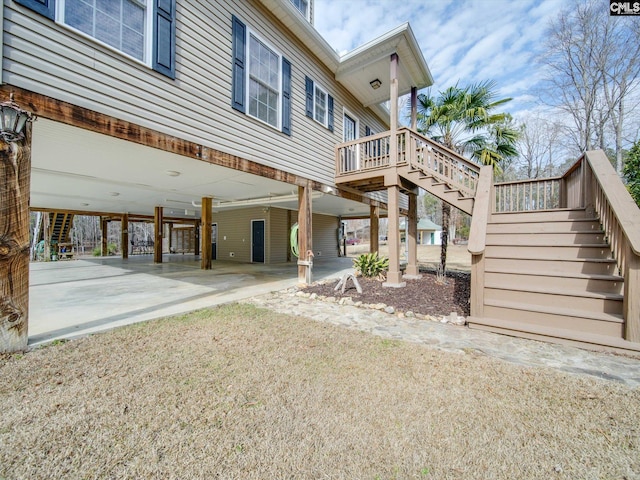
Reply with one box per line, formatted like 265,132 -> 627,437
231,16 -> 291,135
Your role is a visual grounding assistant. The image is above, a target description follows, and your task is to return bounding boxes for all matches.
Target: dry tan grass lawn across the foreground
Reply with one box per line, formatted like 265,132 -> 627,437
0,305 -> 640,479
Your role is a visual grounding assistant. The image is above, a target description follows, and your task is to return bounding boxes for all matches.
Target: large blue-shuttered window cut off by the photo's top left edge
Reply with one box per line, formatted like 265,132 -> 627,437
15,0 -> 176,78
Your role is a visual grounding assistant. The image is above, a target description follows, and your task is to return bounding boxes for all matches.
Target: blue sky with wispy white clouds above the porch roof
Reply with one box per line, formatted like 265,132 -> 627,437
314,0 -> 576,116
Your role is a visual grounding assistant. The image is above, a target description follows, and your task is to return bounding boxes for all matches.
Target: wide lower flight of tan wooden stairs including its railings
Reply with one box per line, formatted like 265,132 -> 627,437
467,151 -> 640,352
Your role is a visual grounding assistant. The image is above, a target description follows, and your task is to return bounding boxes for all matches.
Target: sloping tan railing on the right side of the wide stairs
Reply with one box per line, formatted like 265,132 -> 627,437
574,150 -> 640,342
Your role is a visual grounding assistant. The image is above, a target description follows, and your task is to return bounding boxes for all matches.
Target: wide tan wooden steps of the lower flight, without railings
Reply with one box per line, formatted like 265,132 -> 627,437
468,208 -> 640,348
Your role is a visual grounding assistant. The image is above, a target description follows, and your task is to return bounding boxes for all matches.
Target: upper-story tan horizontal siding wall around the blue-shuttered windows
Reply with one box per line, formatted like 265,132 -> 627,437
2,0 -> 385,187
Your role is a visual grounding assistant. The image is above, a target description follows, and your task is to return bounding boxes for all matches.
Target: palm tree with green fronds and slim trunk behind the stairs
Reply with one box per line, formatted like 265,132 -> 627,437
418,81 -> 518,275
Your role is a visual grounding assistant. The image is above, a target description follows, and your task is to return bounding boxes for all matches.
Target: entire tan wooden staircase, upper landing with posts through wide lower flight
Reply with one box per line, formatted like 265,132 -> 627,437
335,128 -> 640,352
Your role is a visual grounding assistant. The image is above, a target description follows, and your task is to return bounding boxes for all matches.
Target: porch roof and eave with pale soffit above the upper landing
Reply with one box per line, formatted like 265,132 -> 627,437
259,0 -> 433,116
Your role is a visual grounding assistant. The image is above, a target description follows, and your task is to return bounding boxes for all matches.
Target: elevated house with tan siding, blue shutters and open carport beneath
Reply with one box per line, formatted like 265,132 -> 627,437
2,0 -> 432,268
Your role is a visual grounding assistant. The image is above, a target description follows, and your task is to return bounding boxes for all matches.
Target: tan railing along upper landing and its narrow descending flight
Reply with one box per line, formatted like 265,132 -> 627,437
336,128 -> 480,197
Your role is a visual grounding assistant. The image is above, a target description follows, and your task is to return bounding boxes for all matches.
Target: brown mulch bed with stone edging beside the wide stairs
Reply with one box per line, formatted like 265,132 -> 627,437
305,270 -> 471,317
